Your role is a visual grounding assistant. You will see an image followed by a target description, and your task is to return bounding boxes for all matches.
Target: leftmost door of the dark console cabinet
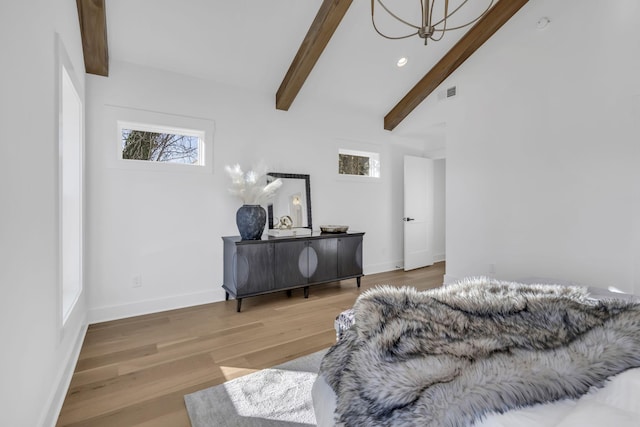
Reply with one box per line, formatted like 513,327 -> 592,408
233,243 -> 275,297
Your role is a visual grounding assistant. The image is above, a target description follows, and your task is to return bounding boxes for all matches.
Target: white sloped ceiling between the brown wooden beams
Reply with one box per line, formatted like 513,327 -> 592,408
106,0 -> 496,134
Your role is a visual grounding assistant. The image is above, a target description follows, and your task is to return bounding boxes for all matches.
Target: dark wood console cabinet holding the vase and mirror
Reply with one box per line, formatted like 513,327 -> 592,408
222,232 -> 364,312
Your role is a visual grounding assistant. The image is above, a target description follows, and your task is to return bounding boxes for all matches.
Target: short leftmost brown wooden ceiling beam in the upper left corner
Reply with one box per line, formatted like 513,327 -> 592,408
76,0 -> 109,77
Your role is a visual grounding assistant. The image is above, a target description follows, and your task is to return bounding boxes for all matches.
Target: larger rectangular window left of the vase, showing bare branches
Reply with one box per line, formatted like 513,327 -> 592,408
118,122 -> 204,166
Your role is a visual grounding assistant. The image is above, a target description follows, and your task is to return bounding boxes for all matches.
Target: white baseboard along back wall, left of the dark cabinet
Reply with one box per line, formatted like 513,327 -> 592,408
87,288 -> 224,324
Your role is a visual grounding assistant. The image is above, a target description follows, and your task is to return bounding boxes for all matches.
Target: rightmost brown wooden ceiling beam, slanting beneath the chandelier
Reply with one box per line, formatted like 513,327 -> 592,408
384,0 -> 528,130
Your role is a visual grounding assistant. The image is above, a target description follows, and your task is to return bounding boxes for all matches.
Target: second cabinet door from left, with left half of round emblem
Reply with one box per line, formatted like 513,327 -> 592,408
275,241 -> 309,289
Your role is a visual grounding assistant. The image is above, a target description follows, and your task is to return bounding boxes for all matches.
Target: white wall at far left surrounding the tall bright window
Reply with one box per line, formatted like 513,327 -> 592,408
0,0 -> 86,426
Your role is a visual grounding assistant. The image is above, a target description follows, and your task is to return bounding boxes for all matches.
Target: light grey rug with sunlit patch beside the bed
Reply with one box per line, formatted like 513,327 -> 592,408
184,350 -> 326,427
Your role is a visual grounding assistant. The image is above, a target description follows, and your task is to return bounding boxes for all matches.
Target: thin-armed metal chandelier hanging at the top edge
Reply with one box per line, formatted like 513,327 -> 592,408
371,0 -> 495,45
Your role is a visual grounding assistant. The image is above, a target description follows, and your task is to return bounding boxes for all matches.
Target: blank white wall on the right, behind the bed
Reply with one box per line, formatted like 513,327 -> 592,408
415,0 -> 640,293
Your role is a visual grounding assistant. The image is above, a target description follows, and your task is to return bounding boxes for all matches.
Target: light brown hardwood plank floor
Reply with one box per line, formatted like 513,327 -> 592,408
57,262 -> 444,427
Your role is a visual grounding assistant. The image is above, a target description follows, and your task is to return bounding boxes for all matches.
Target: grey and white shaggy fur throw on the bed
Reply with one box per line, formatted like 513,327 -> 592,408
320,278 -> 640,427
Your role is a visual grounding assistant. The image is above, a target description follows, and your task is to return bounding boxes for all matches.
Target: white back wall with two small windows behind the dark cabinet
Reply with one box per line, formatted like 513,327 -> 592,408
87,61 -> 440,321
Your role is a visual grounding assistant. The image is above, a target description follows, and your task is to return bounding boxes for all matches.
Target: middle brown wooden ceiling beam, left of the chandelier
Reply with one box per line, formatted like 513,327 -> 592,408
276,0 -> 352,111
